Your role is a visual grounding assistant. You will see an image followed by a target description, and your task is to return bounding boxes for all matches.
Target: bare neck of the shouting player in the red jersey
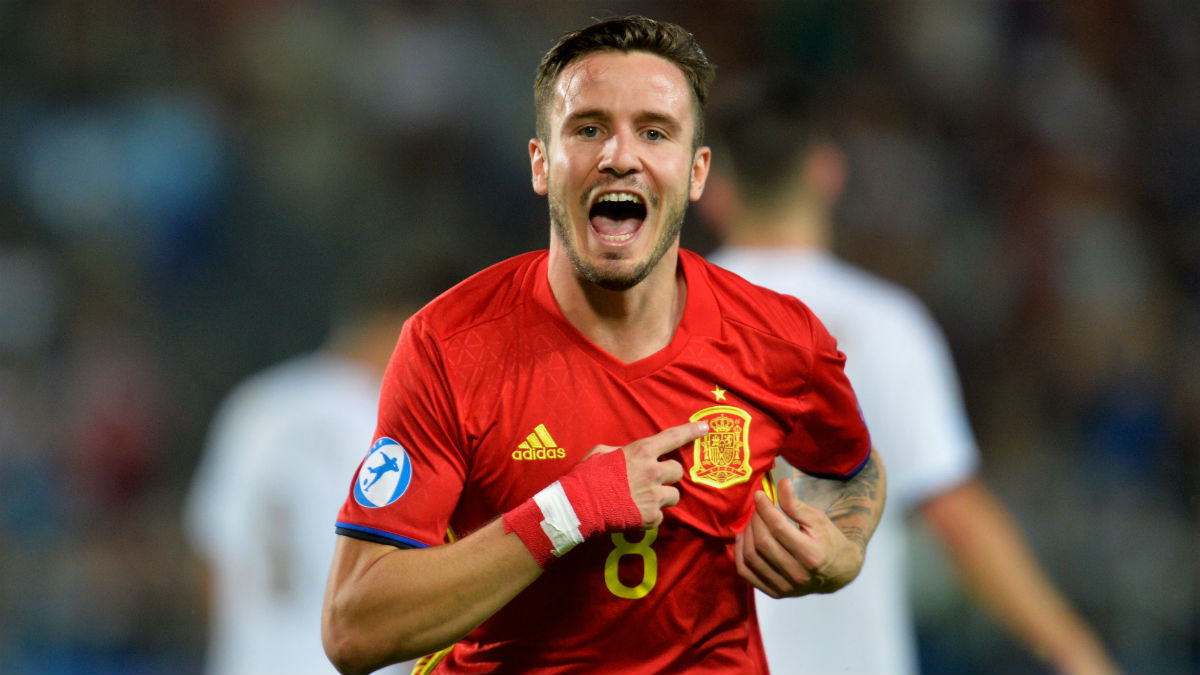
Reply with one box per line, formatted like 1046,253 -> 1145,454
550,246 -> 688,363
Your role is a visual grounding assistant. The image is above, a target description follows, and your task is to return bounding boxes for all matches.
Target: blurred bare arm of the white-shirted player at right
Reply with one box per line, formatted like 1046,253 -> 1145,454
920,480 -> 1118,673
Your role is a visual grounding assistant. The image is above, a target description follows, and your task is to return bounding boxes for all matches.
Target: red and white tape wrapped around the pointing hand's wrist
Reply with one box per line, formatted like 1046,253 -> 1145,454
502,450 -> 642,567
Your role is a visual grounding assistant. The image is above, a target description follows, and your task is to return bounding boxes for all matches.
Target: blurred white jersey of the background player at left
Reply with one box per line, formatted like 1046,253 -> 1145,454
185,353 -> 403,674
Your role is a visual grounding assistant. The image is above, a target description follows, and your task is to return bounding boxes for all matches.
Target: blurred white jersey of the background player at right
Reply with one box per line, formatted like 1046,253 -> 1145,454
709,247 -> 978,675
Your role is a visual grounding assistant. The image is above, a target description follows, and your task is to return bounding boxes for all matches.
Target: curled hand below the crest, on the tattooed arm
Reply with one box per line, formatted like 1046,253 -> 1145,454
733,480 -> 865,598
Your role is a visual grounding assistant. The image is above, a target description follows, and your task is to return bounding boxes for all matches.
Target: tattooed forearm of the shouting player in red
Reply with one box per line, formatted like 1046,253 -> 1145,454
792,449 -> 887,555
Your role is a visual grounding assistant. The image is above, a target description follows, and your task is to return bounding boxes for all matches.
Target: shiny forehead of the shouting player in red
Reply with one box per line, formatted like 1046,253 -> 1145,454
553,52 -> 692,123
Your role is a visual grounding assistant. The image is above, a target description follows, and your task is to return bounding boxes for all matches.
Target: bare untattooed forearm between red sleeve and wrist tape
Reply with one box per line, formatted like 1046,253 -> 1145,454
322,520 -> 541,673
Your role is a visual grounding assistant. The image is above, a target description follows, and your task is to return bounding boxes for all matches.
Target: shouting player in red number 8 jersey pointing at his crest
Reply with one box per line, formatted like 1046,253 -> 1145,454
323,17 -> 884,675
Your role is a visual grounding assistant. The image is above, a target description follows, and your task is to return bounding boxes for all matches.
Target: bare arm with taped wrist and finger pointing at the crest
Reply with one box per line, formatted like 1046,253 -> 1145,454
322,423 -> 708,673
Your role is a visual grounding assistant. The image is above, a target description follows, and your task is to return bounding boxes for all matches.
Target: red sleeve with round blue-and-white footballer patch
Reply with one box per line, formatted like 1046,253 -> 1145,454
337,313 -> 467,548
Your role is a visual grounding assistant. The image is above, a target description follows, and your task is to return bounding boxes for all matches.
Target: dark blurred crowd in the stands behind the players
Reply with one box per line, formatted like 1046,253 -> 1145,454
0,0 -> 1200,673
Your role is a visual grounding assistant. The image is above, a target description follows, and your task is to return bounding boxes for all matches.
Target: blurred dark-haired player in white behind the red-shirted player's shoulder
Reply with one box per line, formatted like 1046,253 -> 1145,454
700,83 -> 1118,675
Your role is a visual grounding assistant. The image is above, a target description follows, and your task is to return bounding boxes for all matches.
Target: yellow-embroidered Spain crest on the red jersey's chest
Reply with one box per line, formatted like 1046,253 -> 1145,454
691,406 -> 751,489
